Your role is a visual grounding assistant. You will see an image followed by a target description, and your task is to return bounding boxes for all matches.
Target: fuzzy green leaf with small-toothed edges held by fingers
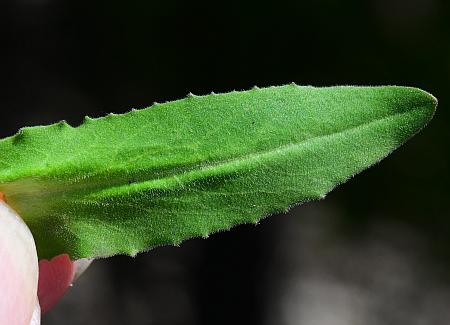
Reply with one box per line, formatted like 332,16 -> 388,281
0,85 -> 437,258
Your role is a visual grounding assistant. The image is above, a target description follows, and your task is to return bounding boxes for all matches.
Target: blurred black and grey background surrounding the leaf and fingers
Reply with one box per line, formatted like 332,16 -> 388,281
0,0 -> 450,325
